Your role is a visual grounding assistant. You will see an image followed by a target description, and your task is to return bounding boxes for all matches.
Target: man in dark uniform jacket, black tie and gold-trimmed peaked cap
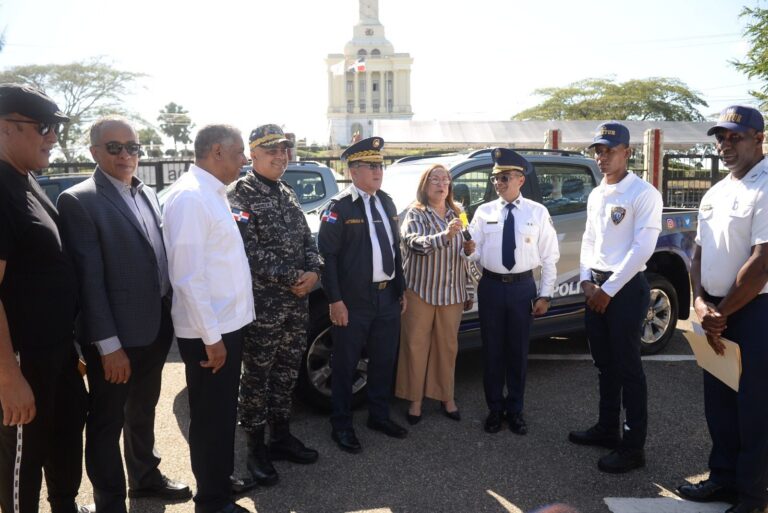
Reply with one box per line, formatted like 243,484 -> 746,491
318,137 -> 408,453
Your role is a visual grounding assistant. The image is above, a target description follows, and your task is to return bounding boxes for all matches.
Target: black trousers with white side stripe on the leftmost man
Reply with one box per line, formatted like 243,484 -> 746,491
0,342 -> 87,513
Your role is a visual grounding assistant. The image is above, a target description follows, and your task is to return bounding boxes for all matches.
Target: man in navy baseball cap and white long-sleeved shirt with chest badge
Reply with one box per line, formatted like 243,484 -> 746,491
568,122 -> 662,473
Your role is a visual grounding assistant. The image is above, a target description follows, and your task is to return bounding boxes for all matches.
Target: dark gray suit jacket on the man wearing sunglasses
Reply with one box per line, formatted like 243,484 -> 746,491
57,167 -> 169,347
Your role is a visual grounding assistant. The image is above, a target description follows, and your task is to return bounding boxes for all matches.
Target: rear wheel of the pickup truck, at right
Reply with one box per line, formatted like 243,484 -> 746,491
640,273 -> 679,355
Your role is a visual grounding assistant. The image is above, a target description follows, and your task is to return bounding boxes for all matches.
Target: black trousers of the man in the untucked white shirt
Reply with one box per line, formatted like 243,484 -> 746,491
178,329 -> 243,513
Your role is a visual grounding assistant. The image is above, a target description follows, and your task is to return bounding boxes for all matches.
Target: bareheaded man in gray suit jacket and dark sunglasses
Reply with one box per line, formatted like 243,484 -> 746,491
58,117 -> 192,513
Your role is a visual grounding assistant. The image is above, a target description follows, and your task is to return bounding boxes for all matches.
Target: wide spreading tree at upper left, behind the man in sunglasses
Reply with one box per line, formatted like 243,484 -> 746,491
0,58 -> 145,162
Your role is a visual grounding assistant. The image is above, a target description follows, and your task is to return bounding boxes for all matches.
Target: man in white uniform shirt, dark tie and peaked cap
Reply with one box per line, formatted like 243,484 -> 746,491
469,148 -> 560,435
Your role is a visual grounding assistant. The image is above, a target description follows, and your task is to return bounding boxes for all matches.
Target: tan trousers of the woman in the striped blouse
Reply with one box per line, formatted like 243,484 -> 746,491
395,290 -> 464,401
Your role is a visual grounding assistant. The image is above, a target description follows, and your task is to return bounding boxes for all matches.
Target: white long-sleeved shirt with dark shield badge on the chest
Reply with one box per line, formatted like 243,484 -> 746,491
579,172 -> 663,297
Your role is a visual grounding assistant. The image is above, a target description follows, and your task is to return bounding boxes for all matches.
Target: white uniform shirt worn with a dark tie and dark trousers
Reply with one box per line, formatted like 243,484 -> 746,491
469,194 -> 560,297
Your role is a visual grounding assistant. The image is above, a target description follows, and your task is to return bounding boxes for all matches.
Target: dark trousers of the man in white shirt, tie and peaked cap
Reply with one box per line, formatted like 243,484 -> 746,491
477,277 -> 536,415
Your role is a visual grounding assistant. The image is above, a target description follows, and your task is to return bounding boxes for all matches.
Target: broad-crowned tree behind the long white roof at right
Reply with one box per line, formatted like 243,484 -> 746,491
512,77 -> 707,121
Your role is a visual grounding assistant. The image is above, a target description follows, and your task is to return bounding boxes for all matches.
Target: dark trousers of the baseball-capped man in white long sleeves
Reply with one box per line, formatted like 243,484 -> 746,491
585,273 -> 651,449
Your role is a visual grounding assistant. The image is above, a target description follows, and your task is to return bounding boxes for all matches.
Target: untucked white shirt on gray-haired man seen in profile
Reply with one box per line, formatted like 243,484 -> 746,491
163,165 -> 255,345
